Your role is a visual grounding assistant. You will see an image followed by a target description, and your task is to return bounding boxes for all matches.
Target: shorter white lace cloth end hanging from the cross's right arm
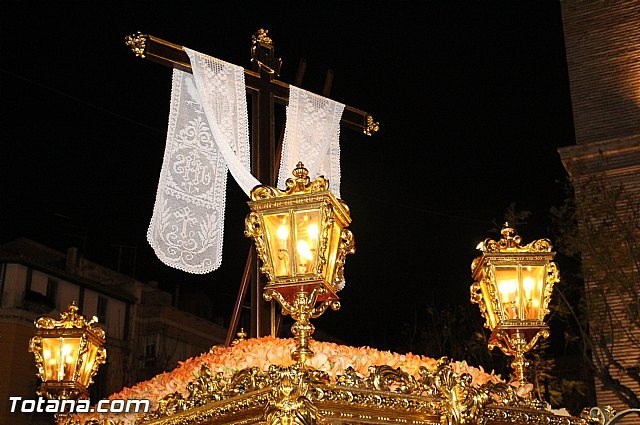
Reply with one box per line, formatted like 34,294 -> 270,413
278,86 -> 344,198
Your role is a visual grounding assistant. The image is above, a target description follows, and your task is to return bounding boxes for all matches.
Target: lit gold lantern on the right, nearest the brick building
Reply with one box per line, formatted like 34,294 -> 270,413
471,223 -> 559,386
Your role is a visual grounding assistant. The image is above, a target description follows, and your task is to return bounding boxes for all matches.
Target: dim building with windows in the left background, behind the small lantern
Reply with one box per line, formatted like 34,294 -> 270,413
0,239 -> 226,425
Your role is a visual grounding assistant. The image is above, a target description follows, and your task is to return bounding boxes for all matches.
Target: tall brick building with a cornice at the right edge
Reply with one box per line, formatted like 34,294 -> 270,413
559,0 -> 640,410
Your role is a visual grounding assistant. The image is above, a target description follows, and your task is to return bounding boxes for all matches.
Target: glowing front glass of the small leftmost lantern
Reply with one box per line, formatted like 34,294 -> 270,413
42,337 -> 80,381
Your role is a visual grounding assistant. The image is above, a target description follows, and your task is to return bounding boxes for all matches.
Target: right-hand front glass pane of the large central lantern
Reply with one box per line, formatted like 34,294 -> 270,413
294,209 -> 320,274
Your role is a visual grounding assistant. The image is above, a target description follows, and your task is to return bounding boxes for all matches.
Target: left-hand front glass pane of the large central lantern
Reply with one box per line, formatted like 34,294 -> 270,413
264,213 -> 293,277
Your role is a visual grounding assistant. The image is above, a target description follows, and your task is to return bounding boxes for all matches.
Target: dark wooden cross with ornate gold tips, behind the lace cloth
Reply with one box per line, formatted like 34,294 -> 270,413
125,29 -> 378,346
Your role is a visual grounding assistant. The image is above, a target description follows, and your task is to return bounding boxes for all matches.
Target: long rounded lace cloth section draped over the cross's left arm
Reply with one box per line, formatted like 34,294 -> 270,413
147,49 -> 260,274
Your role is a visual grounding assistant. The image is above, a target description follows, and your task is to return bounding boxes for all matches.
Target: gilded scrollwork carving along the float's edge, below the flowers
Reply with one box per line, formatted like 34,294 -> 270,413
66,358 -> 586,425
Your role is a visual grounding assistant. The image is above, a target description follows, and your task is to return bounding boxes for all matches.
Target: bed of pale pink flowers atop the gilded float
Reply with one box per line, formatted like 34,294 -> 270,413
66,337 -> 503,425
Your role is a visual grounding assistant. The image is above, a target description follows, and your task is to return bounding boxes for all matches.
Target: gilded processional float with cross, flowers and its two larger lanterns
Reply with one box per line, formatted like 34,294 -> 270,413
50,30 -> 624,425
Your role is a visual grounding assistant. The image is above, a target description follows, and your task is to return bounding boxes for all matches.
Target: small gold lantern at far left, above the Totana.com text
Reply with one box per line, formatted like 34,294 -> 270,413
29,302 -> 107,399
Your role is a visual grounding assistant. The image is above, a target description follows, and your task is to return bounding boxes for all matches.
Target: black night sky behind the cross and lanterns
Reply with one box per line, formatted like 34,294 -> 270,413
0,0 -> 574,348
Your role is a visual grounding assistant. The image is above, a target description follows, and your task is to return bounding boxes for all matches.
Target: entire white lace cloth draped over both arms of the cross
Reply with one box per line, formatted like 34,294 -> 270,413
147,52 -> 344,274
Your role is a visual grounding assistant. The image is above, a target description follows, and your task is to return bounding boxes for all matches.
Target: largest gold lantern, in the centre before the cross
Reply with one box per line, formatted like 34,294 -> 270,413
245,162 -> 354,363
